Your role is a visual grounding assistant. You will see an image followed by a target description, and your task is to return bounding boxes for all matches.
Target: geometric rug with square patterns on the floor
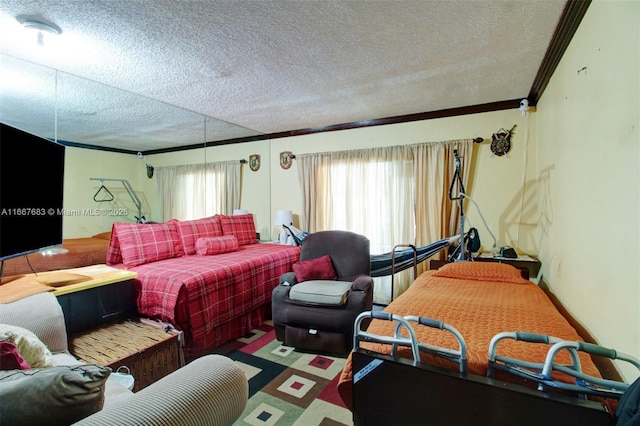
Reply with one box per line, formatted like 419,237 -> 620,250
215,322 -> 353,426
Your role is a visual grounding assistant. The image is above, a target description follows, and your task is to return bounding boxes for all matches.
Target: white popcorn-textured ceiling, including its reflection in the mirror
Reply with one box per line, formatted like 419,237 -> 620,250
0,0 -> 565,151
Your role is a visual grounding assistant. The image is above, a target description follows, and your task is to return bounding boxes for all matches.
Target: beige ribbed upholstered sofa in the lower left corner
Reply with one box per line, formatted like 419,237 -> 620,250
0,293 -> 248,426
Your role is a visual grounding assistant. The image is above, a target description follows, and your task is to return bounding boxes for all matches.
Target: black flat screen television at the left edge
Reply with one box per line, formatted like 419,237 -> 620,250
0,123 -> 65,262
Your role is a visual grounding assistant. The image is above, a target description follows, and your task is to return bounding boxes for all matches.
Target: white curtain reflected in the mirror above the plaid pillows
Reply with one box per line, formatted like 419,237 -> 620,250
156,161 -> 240,220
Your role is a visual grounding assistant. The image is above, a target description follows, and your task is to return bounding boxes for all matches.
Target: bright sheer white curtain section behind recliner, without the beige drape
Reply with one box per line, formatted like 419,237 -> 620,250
296,146 -> 415,303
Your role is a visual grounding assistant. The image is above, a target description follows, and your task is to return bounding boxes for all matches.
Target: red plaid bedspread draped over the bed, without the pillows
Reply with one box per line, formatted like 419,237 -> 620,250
129,243 -> 300,354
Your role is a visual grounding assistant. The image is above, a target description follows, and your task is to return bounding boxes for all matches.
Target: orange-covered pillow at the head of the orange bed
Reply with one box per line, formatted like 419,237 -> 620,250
433,262 -> 530,284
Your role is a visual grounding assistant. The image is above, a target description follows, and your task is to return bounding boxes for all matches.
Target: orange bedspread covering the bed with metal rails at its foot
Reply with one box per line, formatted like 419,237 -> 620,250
338,262 -> 600,407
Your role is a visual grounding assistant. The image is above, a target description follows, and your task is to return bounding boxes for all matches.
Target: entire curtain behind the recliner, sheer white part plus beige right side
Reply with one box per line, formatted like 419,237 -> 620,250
296,139 -> 473,303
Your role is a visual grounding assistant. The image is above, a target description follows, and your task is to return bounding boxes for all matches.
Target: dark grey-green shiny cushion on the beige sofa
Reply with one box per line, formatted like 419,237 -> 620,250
0,365 -> 111,425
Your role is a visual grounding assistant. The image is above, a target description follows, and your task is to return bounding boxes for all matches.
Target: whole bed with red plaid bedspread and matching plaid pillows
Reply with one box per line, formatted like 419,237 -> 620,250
107,215 -> 300,357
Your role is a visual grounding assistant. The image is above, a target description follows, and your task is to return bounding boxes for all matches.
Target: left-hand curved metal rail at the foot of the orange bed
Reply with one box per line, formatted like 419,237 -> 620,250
353,311 -> 467,374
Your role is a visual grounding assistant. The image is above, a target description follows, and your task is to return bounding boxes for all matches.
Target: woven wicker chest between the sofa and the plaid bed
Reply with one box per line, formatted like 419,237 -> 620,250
69,320 -> 184,392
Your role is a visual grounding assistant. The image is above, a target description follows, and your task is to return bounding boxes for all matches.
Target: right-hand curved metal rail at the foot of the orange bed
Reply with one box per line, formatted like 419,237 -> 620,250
487,332 -> 640,399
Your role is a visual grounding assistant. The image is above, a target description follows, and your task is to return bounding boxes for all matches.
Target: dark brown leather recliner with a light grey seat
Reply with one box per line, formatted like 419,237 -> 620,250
272,231 -> 373,353
